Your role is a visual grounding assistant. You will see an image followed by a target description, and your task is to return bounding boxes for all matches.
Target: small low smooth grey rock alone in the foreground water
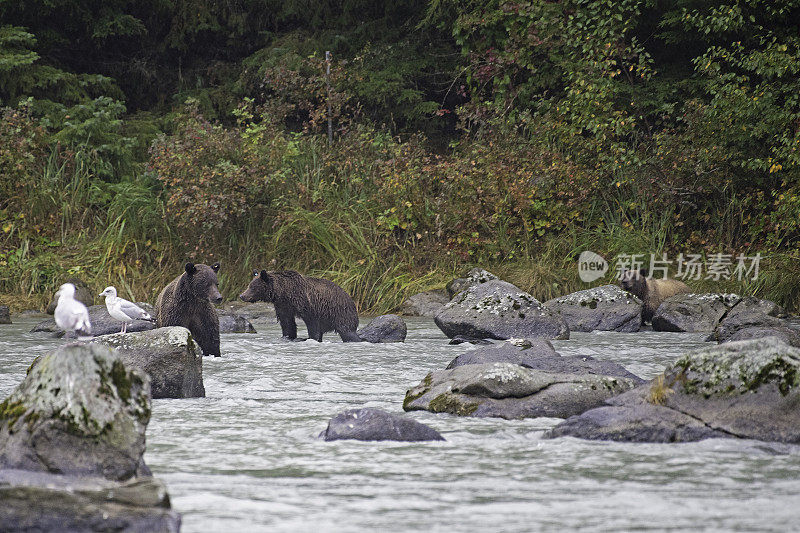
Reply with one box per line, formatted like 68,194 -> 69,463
320,408 -> 444,442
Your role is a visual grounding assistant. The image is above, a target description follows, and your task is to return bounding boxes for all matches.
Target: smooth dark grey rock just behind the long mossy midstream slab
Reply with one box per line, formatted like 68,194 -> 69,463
446,339 -> 644,385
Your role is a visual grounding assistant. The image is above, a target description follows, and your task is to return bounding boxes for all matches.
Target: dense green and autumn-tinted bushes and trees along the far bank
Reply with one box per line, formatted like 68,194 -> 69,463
0,0 -> 800,312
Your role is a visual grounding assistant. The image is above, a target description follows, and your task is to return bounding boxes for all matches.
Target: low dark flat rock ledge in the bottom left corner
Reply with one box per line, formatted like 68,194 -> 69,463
0,470 -> 181,533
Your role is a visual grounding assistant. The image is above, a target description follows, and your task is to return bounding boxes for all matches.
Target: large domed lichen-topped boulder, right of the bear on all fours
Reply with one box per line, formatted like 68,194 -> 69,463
434,280 -> 569,340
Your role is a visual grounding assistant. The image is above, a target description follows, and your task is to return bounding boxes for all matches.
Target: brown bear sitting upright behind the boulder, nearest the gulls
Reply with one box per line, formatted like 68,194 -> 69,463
156,263 -> 222,357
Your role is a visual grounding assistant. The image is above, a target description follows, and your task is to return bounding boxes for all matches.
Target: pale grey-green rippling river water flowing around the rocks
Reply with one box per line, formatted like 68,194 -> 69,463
0,319 -> 800,533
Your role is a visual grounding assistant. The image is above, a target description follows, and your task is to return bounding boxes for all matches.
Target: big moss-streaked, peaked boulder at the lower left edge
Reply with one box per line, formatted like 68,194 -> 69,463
0,344 -> 150,481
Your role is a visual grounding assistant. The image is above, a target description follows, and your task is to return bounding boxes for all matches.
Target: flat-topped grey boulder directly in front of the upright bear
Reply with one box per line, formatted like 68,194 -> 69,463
93,326 -> 206,398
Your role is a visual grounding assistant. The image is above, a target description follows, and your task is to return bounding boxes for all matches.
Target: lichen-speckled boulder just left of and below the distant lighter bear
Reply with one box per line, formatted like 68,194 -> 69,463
542,285 -> 642,333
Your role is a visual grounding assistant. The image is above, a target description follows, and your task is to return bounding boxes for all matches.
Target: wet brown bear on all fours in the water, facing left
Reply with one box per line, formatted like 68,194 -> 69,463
239,270 -> 361,342
